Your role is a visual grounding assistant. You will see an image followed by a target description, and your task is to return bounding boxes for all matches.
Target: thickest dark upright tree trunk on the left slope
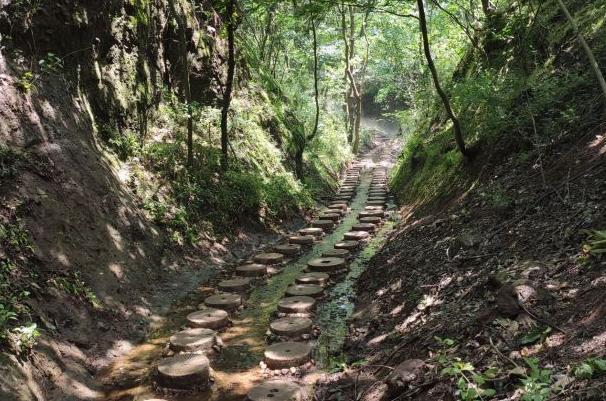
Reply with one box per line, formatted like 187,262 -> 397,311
221,0 -> 236,171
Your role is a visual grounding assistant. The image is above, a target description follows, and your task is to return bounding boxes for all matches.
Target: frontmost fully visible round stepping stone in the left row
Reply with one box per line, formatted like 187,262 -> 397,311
158,351 -> 211,390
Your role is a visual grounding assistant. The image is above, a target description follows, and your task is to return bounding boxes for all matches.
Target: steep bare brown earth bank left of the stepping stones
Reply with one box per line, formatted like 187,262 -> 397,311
0,0 -> 228,400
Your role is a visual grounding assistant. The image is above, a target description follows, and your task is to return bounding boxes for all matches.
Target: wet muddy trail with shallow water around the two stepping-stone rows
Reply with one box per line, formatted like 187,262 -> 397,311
99,128 -> 399,401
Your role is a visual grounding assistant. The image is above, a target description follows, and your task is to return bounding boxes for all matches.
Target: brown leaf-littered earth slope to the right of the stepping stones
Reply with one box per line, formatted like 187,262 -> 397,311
316,127 -> 606,401
